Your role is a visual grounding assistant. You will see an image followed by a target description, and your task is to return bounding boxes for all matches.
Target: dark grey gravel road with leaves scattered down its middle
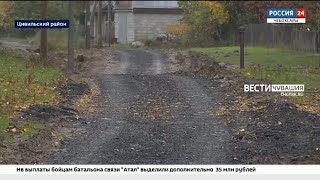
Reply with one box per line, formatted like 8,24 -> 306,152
49,50 -> 234,164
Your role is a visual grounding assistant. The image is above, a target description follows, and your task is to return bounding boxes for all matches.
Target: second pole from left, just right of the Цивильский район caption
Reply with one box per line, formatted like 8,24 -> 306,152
68,1 -> 75,71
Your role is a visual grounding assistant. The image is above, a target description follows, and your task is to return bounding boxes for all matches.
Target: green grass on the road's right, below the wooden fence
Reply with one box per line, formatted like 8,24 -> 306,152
191,46 -> 320,89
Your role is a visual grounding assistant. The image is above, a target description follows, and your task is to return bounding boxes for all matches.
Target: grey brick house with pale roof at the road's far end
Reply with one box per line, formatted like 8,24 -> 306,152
114,1 -> 183,43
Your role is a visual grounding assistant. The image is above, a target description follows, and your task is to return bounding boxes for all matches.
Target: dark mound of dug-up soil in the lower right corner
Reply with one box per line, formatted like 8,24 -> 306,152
230,100 -> 320,164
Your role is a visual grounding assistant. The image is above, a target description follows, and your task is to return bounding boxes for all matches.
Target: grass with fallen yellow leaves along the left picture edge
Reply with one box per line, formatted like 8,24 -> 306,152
0,48 -> 59,141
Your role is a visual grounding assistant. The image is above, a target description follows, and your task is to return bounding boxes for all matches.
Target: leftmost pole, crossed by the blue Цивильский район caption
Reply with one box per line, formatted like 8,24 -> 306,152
40,1 -> 48,65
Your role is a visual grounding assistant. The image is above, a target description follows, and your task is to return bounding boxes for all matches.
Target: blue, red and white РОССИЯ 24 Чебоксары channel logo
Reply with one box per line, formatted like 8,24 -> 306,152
267,8 -> 306,23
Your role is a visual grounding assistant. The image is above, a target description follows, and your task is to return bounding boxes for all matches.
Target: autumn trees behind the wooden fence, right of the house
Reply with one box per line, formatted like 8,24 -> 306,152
171,0 -> 320,46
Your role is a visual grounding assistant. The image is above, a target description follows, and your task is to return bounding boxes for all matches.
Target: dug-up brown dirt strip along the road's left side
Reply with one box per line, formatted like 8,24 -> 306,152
0,49 -> 111,164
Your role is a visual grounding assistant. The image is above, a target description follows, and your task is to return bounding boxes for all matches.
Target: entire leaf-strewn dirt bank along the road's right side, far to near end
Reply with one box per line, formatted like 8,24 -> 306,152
167,50 -> 320,164
